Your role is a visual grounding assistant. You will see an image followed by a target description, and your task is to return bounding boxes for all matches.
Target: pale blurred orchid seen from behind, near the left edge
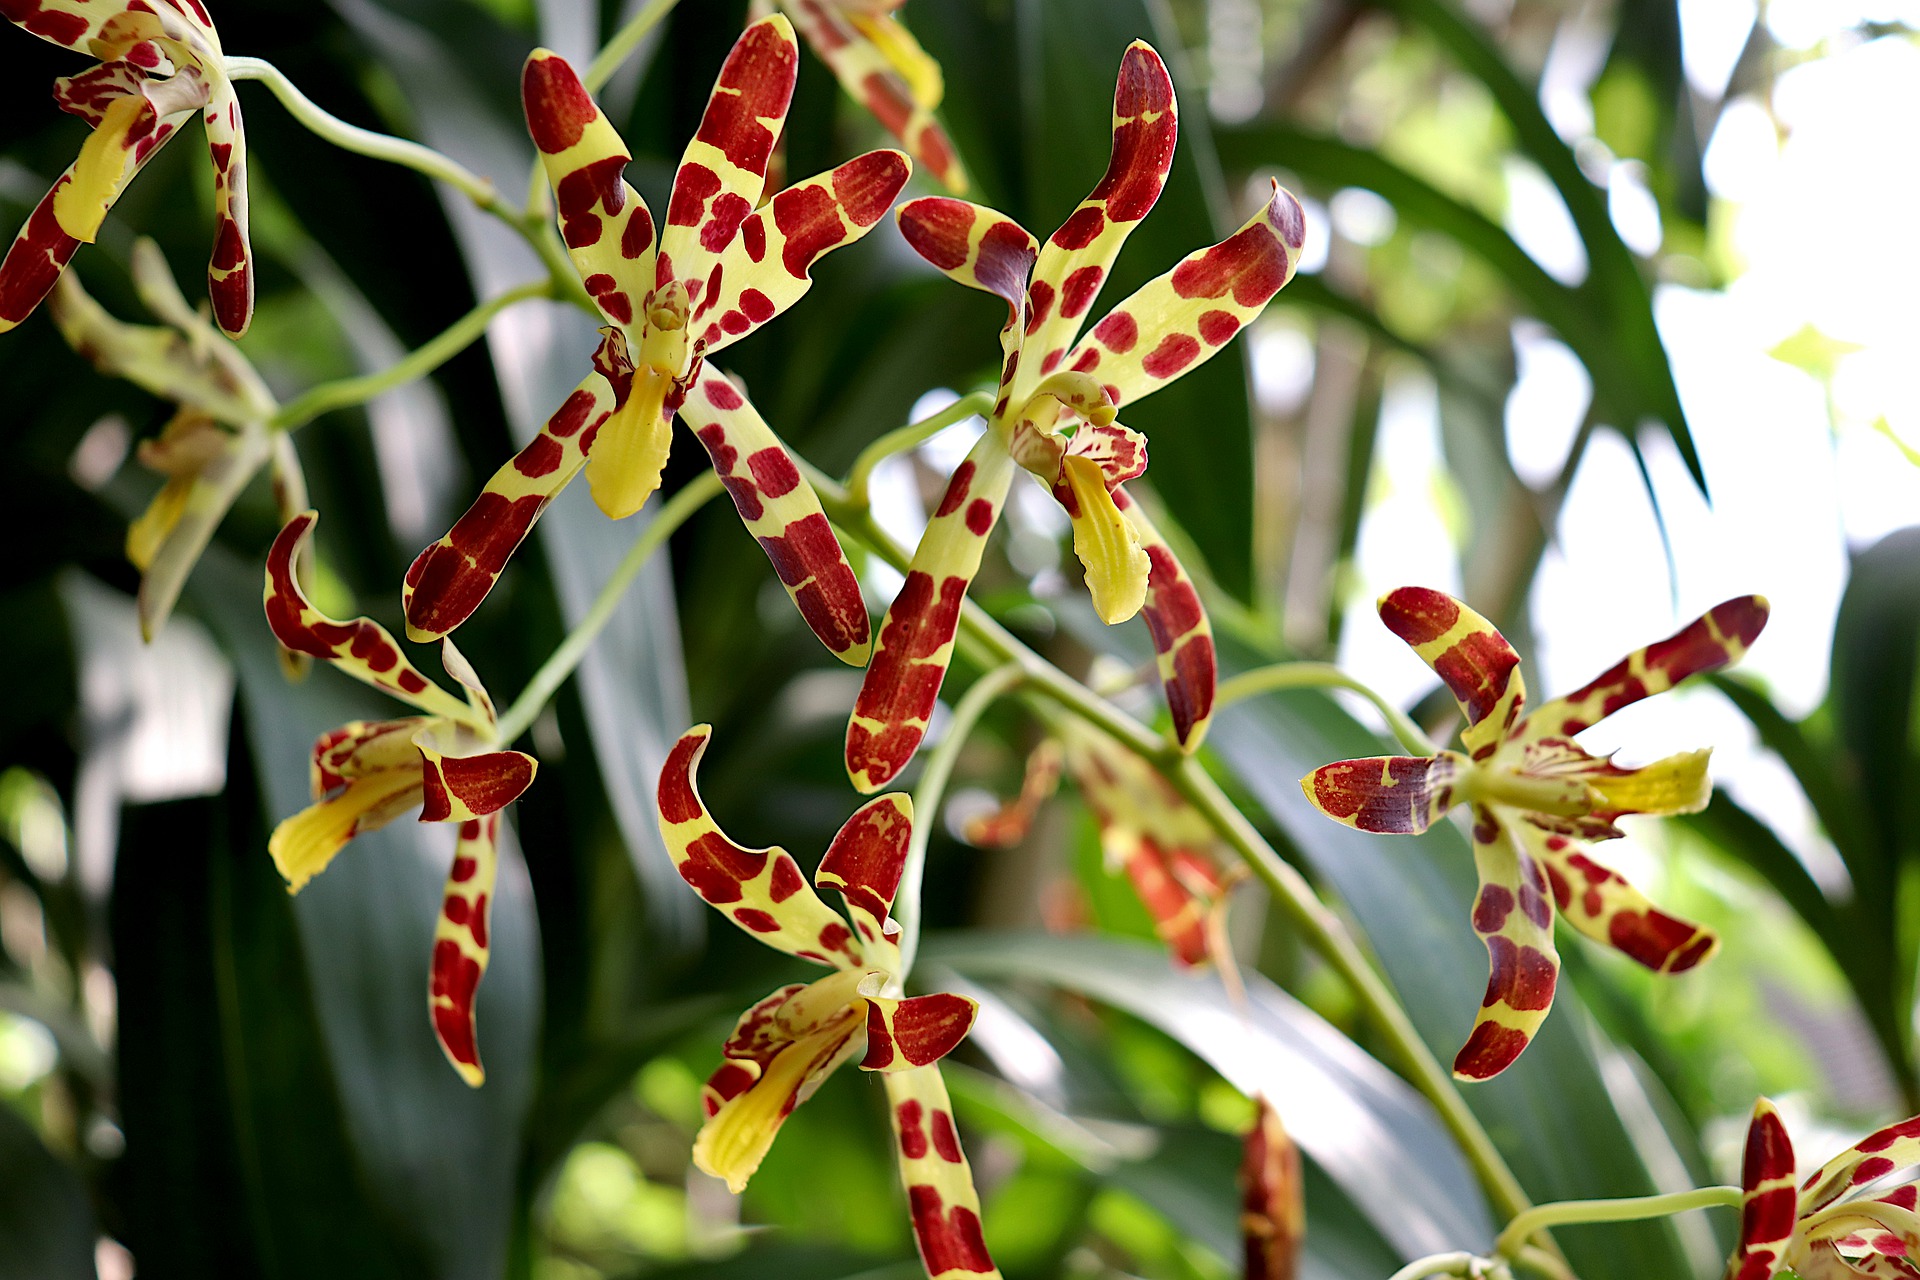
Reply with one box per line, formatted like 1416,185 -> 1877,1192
52,240 -> 291,639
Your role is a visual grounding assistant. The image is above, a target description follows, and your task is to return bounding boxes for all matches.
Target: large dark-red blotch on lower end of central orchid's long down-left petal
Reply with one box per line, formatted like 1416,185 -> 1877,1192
847,570 -> 966,785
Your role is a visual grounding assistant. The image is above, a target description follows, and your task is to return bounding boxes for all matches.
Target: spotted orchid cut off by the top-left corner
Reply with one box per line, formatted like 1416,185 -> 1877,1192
0,0 -> 253,338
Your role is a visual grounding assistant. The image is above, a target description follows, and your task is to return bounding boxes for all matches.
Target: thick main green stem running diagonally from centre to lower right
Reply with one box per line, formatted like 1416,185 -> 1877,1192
803,462 -> 1532,1219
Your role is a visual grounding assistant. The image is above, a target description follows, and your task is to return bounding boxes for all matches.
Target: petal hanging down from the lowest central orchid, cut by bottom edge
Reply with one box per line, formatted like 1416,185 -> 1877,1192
881,1065 -> 1000,1280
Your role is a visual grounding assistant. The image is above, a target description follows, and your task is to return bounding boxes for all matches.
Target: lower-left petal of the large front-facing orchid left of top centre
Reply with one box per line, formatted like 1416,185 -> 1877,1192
401,330 -> 632,641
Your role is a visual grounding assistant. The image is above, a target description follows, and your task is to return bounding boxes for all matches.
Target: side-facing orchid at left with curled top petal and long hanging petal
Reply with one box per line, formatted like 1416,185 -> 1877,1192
265,510 -> 538,1086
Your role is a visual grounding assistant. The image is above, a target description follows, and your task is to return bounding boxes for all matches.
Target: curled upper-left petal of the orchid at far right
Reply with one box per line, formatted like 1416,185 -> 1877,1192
1380,587 -> 1526,760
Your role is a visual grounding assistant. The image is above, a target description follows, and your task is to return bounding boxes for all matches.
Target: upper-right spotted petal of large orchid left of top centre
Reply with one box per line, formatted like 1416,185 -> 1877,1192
693,152 -> 912,355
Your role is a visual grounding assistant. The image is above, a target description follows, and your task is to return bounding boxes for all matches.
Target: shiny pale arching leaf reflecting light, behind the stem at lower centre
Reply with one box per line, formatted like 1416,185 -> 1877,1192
924,933 -> 1494,1259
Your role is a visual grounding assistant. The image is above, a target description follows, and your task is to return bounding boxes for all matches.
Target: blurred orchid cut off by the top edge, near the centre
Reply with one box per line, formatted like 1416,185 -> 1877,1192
749,0 -> 968,196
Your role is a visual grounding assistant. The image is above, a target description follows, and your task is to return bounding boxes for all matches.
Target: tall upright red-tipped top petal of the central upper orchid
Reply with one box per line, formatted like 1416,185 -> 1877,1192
1016,40 -> 1179,399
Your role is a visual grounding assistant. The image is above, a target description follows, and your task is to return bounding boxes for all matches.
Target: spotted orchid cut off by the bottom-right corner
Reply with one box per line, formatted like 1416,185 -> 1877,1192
1726,1098 -> 1920,1280
